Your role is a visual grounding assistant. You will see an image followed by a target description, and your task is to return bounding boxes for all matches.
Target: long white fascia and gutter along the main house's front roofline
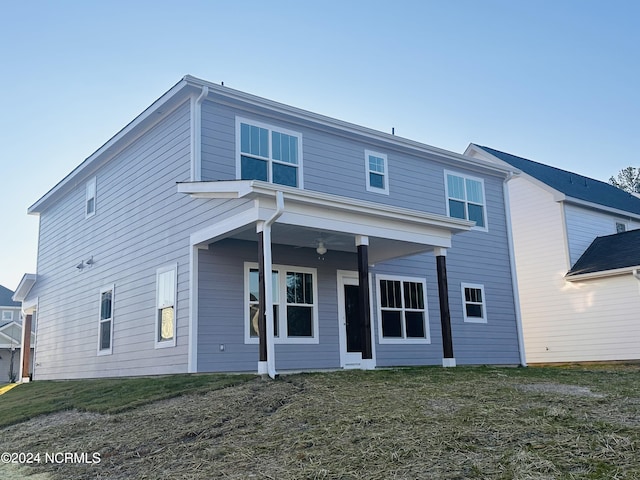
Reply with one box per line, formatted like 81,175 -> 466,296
184,75 -> 513,175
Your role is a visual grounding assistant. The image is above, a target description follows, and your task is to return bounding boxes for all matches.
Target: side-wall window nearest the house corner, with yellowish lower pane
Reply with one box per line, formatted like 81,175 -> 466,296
156,265 -> 178,348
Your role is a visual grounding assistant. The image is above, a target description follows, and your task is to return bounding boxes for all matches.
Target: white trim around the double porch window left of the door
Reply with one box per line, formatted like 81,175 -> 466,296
242,262 -> 320,345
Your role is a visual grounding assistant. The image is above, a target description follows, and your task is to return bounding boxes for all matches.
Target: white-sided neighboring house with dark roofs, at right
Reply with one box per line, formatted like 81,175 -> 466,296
465,144 -> 640,363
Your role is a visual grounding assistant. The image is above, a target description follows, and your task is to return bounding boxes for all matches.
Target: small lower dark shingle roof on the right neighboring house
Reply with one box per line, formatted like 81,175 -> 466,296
566,229 -> 640,280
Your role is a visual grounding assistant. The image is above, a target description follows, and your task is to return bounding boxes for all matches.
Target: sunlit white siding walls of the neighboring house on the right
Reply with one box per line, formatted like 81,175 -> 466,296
509,178 -> 640,363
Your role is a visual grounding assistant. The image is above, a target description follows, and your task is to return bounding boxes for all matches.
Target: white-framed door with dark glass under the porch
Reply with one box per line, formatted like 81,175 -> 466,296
338,271 -> 374,368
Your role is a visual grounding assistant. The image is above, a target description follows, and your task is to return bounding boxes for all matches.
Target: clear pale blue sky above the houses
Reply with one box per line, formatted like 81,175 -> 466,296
0,0 -> 640,290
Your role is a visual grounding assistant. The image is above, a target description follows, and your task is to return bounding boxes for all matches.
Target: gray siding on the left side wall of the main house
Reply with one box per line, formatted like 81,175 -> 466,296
30,103 -> 193,379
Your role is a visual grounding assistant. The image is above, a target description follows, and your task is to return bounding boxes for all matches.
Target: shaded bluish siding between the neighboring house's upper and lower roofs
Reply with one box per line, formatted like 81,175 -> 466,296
564,203 -> 640,266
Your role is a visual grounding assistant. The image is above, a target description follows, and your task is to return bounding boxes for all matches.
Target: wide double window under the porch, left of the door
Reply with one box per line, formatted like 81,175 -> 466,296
245,263 -> 319,343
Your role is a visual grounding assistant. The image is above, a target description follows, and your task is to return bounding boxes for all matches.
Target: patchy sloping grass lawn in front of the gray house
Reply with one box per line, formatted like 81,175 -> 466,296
0,365 -> 640,480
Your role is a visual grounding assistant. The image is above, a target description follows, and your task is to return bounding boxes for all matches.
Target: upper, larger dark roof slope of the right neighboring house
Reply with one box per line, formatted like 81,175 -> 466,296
475,145 -> 640,215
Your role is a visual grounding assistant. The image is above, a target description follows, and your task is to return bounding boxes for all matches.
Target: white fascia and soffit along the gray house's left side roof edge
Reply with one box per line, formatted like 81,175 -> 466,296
27,78 -> 195,215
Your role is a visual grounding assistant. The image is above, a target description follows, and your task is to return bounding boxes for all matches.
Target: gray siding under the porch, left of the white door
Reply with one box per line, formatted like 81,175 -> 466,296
198,240 -> 358,372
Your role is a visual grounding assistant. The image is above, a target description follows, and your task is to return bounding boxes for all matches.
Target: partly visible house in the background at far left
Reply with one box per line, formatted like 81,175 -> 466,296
0,285 -> 32,384
